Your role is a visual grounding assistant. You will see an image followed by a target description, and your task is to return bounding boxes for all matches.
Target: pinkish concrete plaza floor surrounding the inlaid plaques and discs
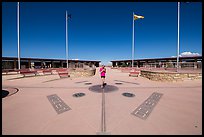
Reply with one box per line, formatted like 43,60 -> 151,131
2,68 -> 202,135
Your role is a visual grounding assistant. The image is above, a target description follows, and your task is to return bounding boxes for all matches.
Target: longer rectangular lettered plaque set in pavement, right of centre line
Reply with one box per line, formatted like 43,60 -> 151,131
131,92 -> 163,120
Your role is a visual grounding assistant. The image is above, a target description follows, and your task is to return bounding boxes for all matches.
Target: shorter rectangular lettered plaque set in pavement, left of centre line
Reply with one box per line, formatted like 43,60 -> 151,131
47,94 -> 71,114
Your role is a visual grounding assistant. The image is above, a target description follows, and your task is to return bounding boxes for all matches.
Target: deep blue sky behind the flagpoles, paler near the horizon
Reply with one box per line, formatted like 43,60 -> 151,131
2,2 -> 202,64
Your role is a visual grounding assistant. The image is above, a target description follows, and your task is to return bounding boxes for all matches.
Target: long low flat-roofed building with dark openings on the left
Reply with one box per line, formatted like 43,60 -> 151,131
2,57 -> 101,69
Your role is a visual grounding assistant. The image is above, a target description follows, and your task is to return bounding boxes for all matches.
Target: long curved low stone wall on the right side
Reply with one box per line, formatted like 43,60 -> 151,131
140,70 -> 202,82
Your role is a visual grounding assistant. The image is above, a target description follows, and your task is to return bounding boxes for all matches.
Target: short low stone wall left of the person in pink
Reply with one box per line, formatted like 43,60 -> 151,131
69,69 -> 96,77
